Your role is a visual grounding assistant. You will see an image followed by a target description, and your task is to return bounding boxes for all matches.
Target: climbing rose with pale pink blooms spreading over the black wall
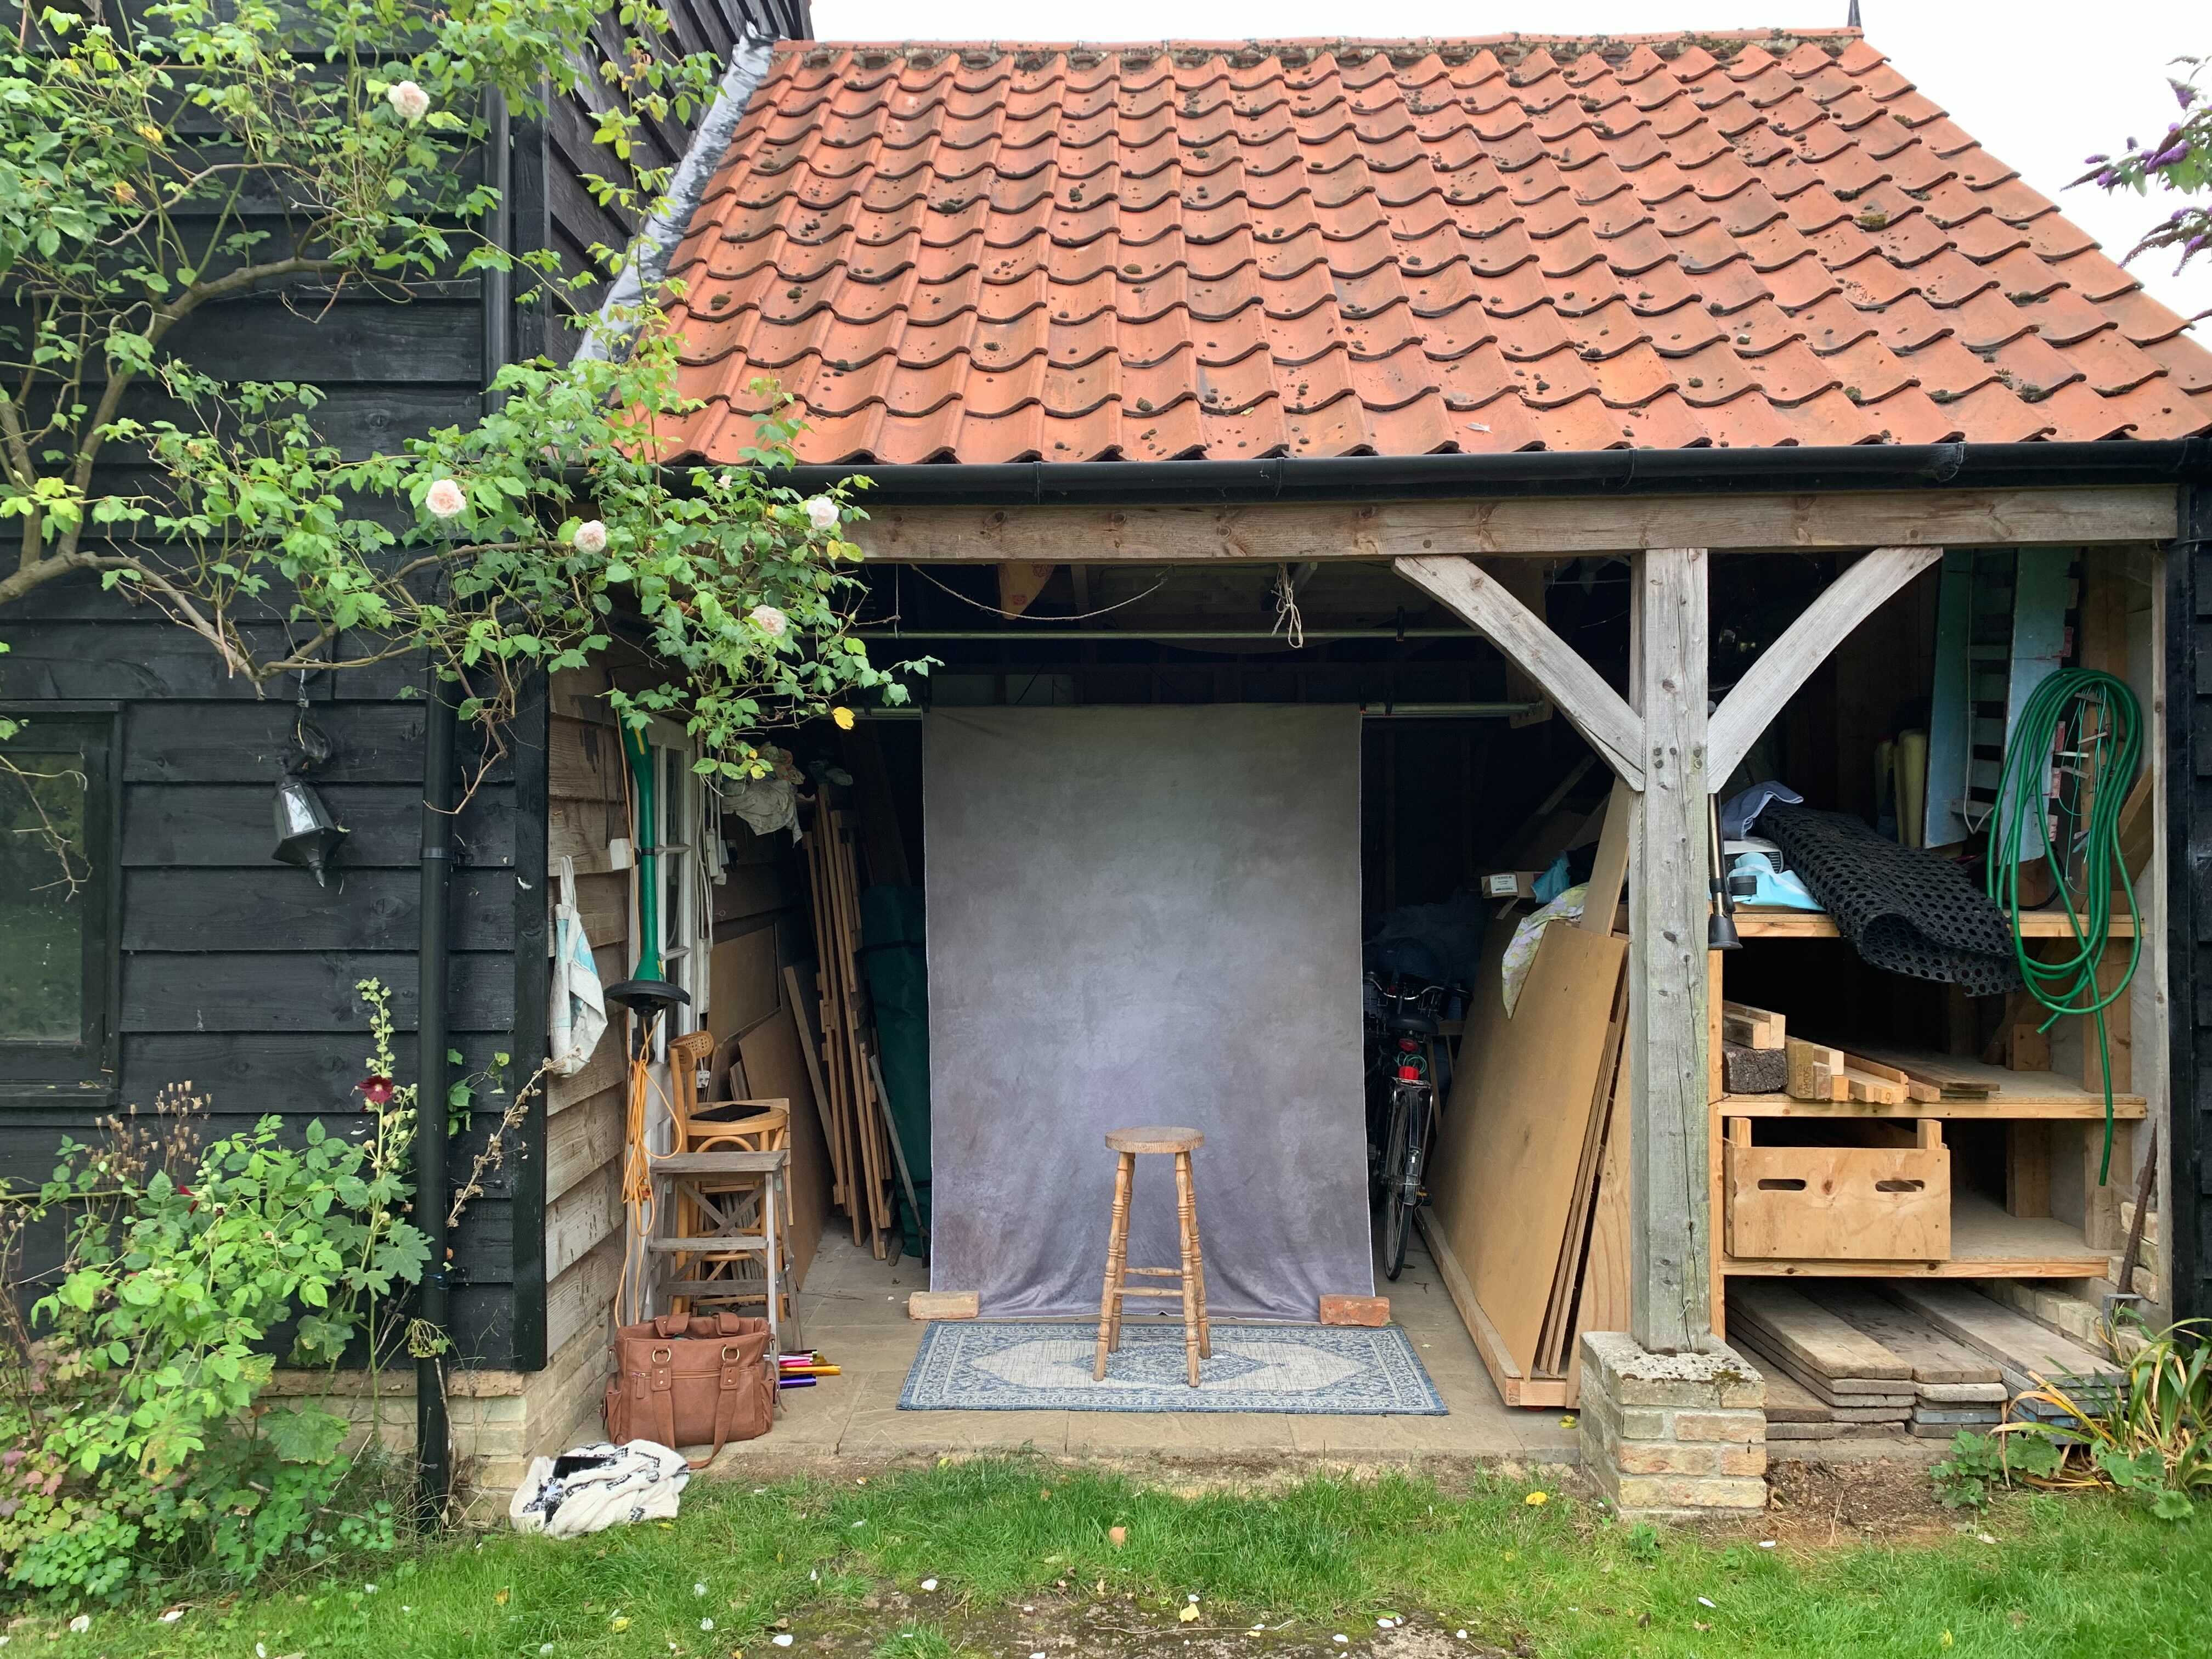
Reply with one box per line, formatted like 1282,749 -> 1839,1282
0,0 -> 905,776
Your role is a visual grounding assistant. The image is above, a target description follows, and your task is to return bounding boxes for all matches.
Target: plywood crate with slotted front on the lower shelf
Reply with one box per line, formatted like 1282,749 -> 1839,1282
1723,1117 -> 1951,1261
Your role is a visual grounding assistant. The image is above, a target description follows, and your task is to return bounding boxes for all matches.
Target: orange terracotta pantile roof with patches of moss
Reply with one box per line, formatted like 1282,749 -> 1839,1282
670,31 -> 2212,462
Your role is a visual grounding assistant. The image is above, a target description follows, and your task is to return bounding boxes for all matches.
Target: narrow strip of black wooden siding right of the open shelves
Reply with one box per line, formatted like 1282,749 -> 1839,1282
2159,484 -> 2212,1318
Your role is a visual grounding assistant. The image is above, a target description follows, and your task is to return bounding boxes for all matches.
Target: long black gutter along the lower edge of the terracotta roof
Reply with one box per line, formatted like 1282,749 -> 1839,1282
743,438 -> 2212,506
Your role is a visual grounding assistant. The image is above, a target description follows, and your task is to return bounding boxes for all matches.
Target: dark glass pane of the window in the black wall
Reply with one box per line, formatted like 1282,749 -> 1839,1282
0,748 -> 91,1042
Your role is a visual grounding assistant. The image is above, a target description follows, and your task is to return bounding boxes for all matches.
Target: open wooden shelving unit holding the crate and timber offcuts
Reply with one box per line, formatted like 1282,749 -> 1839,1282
1708,907 -> 2146,1338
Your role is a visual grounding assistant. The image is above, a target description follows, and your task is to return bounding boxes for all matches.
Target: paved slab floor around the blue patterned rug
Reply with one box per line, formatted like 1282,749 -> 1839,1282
712,1232 -> 1579,1475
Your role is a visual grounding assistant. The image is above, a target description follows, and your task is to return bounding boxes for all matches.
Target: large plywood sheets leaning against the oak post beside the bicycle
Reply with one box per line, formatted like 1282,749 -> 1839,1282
1420,785 -> 1628,1407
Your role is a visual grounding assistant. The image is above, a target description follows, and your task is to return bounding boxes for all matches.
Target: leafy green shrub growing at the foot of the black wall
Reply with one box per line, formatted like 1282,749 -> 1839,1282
0,1070 -> 429,1599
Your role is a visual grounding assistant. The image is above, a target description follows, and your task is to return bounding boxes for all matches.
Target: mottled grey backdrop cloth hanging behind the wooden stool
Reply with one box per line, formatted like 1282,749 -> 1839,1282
922,703 -> 1374,1321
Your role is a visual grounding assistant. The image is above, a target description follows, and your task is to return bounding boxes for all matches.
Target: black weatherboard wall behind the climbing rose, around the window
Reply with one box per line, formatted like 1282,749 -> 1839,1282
0,0 -> 808,1369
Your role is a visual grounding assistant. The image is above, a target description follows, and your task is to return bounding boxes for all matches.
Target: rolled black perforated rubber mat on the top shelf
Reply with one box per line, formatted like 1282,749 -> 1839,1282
1758,801 -> 2019,995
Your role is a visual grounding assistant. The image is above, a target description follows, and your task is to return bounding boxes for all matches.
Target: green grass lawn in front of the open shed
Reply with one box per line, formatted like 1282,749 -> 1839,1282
11,1458 -> 2212,1659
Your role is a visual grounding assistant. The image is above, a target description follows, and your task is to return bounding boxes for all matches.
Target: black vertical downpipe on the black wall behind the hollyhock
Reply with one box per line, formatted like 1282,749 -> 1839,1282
416,666 -> 454,1526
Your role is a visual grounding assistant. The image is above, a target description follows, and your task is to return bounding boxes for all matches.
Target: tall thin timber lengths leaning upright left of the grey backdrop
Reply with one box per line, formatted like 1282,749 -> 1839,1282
792,800 -> 898,1261
